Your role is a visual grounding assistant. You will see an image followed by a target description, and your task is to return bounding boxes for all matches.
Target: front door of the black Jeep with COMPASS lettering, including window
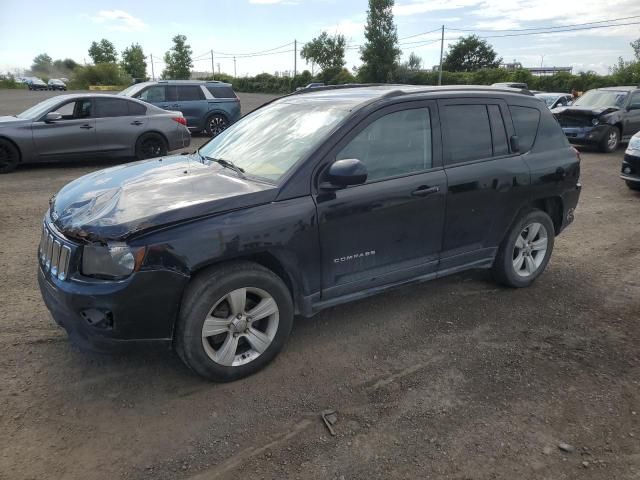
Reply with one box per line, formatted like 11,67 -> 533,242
316,101 -> 447,300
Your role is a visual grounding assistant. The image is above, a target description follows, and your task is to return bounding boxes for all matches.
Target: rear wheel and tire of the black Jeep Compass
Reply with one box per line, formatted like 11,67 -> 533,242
493,210 -> 555,288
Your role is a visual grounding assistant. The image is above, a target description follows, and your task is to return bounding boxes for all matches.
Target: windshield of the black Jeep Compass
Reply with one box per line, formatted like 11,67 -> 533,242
200,100 -> 349,182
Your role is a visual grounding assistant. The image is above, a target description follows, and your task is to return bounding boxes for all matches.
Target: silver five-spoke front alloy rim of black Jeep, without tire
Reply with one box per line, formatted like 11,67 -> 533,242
202,287 -> 279,367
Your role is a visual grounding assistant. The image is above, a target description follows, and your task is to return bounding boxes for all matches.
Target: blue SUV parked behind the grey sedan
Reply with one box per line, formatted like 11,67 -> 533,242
119,80 -> 240,137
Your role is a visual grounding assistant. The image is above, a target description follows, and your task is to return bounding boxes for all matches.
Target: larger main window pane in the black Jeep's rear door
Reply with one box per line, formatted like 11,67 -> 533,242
444,105 -> 493,164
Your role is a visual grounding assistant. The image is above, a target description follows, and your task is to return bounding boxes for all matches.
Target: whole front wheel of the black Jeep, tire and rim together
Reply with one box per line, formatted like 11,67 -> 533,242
174,262 -> 293,382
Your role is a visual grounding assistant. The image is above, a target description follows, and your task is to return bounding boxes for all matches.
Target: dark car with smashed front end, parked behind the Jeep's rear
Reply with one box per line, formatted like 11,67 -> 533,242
553,87 -> 640,153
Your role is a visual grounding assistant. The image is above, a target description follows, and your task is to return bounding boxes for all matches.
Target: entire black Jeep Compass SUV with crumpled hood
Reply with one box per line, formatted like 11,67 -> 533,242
39,85 -> 581,381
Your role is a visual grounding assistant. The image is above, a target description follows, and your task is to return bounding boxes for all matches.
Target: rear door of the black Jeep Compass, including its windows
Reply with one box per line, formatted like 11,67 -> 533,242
438,98 -> 530,271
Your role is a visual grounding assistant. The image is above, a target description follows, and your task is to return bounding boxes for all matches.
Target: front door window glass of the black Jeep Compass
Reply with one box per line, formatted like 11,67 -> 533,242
336,108 -> 432,182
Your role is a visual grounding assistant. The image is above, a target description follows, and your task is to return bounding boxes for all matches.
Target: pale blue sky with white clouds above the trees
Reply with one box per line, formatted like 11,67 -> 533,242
0,0 -> 640,77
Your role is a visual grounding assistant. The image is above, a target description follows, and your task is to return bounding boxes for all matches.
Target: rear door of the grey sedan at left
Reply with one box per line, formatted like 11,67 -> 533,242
96,96 -> 147,155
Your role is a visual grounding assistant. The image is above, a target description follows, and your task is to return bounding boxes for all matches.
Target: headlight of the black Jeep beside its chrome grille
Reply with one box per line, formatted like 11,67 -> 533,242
82,243 -> 144,280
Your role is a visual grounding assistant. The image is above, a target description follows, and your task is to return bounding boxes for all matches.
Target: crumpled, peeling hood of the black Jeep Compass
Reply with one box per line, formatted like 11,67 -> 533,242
49,155 -> 277,241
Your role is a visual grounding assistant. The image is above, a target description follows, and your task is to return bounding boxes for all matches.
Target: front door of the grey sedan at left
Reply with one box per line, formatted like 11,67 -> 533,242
31,97 -> 99,160
